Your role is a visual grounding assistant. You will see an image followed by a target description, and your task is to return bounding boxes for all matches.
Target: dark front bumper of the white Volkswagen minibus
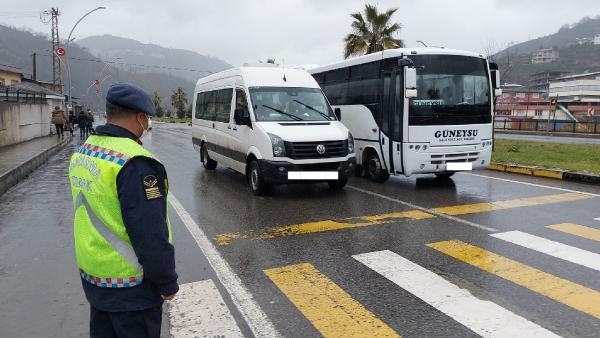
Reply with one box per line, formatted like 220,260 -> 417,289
258,157 -> 356,184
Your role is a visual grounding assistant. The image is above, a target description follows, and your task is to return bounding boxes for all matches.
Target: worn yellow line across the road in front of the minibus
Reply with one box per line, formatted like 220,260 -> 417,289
217,210 -> 435,245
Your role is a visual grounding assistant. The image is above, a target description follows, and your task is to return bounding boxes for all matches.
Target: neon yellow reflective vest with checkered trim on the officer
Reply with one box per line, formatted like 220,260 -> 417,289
69,135 -> 172,288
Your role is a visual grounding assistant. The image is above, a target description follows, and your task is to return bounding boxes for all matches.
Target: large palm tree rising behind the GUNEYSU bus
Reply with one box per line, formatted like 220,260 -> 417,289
344,5 -> 404,59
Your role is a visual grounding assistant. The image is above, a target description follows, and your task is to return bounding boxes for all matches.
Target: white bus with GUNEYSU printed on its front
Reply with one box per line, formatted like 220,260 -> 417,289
308,48 -> 501,182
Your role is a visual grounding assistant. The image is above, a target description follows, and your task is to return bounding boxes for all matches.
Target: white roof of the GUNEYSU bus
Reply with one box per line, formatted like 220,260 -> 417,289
308,47 -> 486,74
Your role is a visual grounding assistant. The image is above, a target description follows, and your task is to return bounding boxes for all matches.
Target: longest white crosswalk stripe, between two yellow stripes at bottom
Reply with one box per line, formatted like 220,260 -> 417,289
352,250 -> 559,337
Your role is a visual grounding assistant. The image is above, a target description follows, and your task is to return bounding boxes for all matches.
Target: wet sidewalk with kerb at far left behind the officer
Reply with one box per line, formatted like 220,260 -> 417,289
0,135 -> 73,195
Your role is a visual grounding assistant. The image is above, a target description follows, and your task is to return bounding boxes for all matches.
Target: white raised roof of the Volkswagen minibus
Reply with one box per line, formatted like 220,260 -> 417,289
196,67 -> 319,89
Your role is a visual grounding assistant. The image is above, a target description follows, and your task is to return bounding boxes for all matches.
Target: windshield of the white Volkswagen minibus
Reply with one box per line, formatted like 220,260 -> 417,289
249,87 -> 335,121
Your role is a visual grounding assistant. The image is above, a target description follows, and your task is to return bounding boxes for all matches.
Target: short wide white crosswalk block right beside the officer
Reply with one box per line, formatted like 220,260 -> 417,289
168,279 -> 244,338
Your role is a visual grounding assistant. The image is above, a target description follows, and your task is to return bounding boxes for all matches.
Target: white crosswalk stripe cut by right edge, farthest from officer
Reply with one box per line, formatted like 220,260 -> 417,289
490,231 -> 600,271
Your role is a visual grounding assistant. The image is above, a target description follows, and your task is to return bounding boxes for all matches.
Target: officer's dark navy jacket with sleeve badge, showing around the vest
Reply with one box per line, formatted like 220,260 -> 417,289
82,124 -> 179,312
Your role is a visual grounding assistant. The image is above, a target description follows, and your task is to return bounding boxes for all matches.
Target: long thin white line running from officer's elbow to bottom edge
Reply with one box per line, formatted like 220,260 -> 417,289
169,192 -> 281,337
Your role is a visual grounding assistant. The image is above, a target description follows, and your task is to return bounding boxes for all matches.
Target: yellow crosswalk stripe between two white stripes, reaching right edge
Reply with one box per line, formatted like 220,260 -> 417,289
427,240 -> 600,318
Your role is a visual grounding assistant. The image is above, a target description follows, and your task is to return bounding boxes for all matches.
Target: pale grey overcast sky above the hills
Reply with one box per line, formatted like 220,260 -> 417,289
0,0 -> 600,66
